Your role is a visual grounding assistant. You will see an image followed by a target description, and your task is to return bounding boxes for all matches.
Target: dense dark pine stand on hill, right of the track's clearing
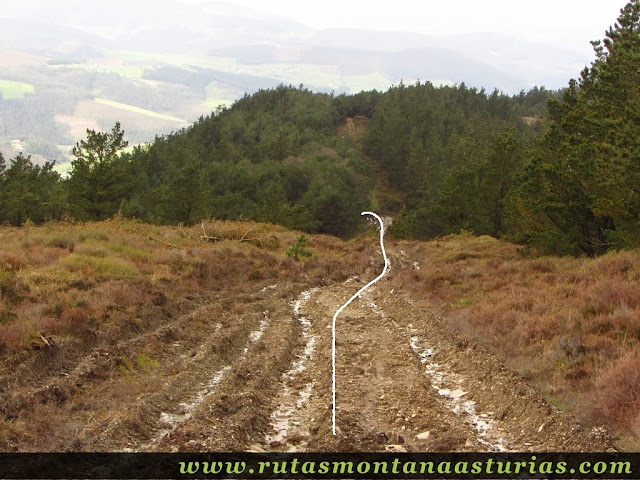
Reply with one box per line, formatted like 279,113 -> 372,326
364,83 -> 545,238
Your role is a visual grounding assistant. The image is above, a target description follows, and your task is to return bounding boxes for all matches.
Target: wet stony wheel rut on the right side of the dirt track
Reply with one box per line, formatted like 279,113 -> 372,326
360,278 -> 613,451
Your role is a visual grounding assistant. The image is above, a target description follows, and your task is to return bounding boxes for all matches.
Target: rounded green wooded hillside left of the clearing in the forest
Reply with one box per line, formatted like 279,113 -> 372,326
124,86 -> 370,235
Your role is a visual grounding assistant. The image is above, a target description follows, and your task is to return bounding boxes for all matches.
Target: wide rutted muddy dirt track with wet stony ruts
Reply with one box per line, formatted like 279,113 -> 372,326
129,255 -> 612,451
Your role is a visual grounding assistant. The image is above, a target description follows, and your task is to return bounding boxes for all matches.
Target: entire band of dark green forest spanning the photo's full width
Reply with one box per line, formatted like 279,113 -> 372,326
0,0 -> 640,255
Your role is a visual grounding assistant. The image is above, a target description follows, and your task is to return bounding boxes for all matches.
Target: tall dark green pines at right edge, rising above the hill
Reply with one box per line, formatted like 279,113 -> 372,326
518,0 -> 640,255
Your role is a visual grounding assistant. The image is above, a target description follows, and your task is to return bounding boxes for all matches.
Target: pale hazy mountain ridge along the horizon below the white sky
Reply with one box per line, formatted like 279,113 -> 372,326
0,1 -> 585,93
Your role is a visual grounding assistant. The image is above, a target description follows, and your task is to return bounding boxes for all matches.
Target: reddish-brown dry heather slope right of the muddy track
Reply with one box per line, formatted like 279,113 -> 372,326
392,234 -> 640,448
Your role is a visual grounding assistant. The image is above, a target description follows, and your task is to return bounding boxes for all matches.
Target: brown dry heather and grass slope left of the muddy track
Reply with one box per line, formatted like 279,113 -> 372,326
0,219 -> 371,451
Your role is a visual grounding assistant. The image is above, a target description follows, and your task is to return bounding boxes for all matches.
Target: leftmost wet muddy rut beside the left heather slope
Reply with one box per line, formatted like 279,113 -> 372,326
79,285 -> 302,451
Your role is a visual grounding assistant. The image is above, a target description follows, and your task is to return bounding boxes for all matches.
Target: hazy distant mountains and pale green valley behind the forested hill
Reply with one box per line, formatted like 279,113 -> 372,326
0,0 -> 589,165
